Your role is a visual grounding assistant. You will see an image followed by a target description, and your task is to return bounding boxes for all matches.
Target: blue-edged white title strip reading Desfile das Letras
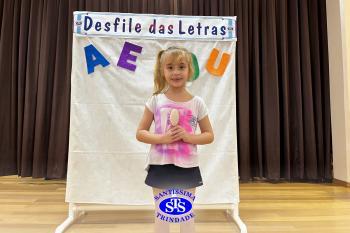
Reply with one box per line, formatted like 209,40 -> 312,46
74,12 -> 236,41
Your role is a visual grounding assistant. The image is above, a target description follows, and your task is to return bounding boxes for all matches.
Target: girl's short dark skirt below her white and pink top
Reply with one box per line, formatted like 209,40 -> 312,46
145,164 -> 203,189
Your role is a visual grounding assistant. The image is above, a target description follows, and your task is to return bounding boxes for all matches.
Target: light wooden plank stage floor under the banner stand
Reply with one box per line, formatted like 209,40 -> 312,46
0,176 -> 350,233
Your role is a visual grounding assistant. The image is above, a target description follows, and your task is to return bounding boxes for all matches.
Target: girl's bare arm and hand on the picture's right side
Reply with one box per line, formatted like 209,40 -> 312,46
174,116 -> 214,145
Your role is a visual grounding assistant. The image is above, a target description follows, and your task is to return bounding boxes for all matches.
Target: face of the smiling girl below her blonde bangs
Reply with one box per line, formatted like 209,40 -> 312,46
163,56 -> 189,88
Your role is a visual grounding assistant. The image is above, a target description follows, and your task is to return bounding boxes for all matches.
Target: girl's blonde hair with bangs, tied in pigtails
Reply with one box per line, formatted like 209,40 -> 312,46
153,46 -> 194,95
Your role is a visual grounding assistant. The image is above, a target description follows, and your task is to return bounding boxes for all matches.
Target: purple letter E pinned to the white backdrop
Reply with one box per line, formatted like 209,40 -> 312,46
117,42 -> 142,71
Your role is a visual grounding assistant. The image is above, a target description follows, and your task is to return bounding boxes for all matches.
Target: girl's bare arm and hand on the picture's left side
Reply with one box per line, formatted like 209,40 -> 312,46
136,107 -> 181,144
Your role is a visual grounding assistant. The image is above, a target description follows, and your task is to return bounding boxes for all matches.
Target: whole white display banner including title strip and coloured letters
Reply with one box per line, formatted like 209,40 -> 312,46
66,12 -> 239,205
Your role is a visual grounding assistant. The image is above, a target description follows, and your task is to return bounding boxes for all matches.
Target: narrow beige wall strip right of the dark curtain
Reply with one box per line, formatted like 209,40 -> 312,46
326,0 -> 350,184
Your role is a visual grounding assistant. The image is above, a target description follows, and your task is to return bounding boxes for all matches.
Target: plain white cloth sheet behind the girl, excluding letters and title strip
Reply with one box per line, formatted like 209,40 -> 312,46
66,11 -> 239,205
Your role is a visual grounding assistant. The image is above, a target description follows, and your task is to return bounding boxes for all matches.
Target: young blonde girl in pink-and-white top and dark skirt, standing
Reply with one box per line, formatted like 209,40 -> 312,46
136,47 -> 214,233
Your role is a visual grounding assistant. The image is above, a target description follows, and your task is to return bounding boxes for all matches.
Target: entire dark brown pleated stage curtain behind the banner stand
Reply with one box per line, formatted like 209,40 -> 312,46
0,0 -> 332,181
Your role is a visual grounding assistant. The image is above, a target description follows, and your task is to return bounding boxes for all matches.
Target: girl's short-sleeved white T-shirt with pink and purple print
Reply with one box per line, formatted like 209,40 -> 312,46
146,93 -> 208,170
